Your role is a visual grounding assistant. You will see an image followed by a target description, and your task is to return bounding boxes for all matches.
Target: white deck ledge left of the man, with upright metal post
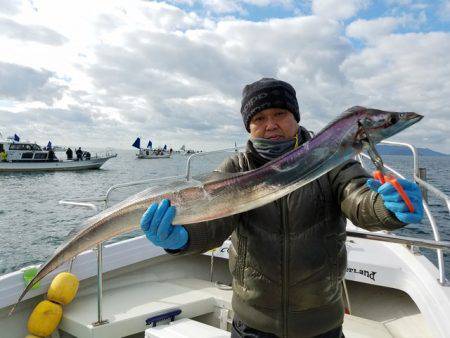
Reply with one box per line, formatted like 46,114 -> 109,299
60,279 -> 232,337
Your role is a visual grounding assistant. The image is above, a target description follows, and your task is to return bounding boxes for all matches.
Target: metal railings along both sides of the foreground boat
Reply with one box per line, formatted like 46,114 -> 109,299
59,141 -> 450,325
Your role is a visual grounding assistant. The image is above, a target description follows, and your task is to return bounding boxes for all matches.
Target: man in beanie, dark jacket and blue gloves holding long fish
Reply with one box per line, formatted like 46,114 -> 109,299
141,78 -> 423,338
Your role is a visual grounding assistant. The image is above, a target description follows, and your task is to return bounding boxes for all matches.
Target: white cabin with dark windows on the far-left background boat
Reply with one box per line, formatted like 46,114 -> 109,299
0,141 -> 56,162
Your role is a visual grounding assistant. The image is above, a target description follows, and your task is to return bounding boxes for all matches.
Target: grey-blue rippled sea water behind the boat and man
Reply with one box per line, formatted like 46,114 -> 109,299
0,150 -> 450,275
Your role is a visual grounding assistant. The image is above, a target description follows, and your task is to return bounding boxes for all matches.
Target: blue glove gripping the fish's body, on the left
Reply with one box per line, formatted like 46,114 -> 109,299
141,199 -> 189,250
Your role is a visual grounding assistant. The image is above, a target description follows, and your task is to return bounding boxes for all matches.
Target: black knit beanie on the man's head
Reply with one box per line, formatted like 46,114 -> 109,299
241,77 -> 300,132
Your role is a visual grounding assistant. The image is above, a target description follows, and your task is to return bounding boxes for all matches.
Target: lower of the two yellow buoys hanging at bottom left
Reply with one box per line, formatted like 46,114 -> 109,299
28,300 -> 62,337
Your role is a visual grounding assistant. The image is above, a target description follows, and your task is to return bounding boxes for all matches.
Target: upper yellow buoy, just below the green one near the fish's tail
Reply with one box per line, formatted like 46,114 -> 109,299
47,272 -> 79,305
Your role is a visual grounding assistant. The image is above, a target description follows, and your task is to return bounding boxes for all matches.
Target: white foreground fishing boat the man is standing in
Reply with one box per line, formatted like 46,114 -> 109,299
0,142 -> 450,338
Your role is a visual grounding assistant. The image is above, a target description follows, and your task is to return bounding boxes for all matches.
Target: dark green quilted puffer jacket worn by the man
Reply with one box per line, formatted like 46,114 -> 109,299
172,131 -> 405,338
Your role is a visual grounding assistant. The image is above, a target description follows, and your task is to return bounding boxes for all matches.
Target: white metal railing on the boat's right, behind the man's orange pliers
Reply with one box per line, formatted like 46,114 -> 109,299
358,141 -> 450,286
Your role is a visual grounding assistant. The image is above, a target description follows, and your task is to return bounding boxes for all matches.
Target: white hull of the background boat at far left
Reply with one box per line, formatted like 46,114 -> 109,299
0,155 -> 117,172
